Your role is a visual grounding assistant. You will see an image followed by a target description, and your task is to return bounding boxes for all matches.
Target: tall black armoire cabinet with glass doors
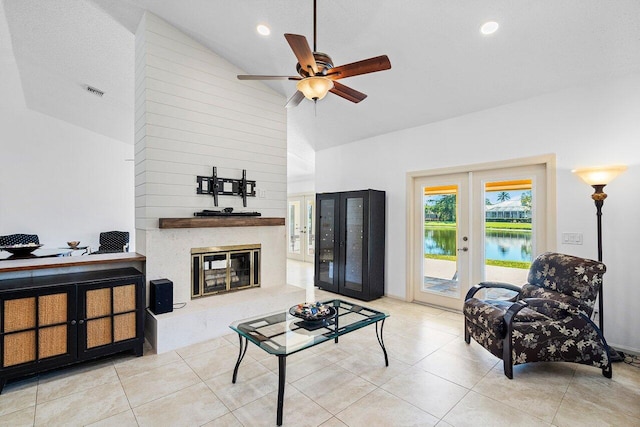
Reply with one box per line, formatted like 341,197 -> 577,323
315,190 -> 385,301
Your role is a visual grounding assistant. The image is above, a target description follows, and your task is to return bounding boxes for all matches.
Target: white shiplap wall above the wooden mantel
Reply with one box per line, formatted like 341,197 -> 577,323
135,12 -> 287,230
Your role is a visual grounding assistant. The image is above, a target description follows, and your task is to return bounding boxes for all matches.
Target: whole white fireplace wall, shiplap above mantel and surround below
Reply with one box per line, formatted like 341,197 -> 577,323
135,12 -> 287,340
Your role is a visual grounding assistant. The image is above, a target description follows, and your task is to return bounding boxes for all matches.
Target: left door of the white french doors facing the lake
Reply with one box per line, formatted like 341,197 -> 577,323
414,173 -> 471,310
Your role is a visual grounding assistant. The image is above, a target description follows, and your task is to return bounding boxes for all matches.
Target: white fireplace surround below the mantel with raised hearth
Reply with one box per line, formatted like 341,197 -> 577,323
144,225 -> 305,353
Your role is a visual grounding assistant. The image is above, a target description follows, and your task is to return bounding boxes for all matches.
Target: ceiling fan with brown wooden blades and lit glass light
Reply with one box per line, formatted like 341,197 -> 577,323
238,0 -> 391,108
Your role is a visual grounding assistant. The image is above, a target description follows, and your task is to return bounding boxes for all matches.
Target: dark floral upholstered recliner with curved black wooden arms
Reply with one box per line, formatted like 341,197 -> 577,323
464,252 -> 612,378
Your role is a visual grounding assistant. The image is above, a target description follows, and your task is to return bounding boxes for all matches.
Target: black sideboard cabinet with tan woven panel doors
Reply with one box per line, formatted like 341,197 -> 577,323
0,268 -> 145,392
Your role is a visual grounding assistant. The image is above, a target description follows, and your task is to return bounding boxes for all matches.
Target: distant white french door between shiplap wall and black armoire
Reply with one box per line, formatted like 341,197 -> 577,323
287,194 -> 316,262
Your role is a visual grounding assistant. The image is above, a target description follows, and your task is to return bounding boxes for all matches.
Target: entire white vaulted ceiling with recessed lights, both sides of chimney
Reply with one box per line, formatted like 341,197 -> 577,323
4,0 -> 640,181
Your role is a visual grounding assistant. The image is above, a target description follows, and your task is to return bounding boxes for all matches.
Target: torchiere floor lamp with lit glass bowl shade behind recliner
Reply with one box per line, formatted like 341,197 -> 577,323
571,165 -> 627,362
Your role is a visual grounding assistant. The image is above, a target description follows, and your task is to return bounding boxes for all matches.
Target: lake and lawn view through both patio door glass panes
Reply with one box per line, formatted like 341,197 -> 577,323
423,180 -> 532,296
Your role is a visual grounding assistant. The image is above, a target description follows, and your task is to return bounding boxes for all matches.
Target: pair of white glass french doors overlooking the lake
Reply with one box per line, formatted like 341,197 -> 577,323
412,164 -> 547,310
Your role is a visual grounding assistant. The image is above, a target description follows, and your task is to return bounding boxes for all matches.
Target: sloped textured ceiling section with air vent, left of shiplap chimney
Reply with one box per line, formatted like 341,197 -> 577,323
4,0 -> 135,143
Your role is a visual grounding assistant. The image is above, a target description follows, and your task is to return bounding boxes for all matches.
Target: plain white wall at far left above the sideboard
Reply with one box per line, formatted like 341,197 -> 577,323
0,8 -> 134,250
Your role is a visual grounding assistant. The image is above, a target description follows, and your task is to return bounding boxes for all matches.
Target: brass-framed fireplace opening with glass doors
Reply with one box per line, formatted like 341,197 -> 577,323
191,244 -> 261,299
